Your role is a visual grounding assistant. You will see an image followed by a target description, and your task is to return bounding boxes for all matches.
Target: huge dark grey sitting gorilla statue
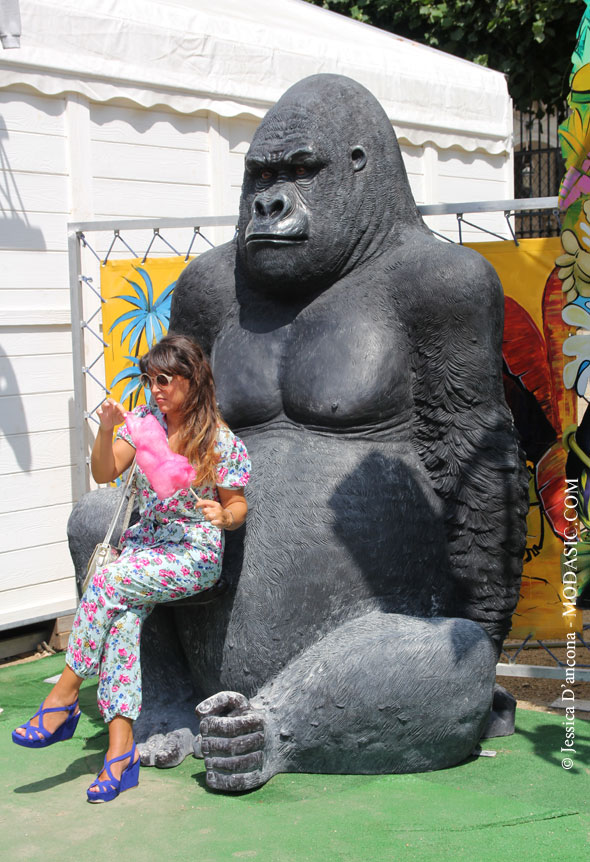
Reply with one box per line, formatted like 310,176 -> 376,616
70,75 -> 527,791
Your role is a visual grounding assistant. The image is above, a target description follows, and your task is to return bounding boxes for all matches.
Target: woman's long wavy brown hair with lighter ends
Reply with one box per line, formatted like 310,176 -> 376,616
139,335 -> 223,485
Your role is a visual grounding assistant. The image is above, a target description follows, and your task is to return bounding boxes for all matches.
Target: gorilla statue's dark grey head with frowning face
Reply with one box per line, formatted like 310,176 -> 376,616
238,75 -> 422,298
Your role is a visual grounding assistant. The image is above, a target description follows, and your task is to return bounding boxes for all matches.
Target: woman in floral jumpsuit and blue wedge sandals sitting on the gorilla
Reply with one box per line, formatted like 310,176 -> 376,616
12,335 -> 250,802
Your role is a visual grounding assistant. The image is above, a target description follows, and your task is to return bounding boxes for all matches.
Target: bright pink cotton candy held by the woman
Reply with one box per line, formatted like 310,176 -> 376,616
125,413 -> 196,500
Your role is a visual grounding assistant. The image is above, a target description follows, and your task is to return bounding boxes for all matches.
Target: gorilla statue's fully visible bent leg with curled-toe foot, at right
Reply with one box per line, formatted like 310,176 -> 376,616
197,611 -> 496,791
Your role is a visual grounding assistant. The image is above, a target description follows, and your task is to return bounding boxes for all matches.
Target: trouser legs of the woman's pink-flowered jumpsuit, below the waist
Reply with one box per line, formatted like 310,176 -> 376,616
66,542 -> 221,722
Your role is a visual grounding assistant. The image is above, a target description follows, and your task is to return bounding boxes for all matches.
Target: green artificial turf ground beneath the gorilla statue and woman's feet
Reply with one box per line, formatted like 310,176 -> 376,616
0,656 -> 590,862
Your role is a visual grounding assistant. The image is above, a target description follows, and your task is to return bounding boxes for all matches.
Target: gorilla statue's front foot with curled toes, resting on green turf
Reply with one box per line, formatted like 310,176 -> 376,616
196,691 -> 272,791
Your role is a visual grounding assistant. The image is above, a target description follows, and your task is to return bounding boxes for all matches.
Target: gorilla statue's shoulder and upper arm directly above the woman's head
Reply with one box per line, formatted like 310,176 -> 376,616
169,240 -> 236,356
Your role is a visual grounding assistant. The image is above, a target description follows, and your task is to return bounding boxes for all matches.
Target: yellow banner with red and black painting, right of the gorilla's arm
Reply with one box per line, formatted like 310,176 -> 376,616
471,237 -> 582,638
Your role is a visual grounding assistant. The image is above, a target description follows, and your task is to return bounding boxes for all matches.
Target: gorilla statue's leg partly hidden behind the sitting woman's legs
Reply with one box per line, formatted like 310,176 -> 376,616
68,488 -> 197,767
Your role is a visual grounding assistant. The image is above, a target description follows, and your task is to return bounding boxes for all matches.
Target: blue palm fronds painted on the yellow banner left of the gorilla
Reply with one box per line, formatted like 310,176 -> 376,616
109,266 -> 176,409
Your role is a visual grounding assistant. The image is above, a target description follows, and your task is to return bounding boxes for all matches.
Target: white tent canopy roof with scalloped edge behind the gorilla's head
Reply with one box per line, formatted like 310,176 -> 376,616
0,0 -> 512,154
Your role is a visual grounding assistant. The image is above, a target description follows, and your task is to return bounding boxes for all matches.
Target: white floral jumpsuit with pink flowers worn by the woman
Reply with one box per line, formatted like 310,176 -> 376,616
66,405 -> 250,722
